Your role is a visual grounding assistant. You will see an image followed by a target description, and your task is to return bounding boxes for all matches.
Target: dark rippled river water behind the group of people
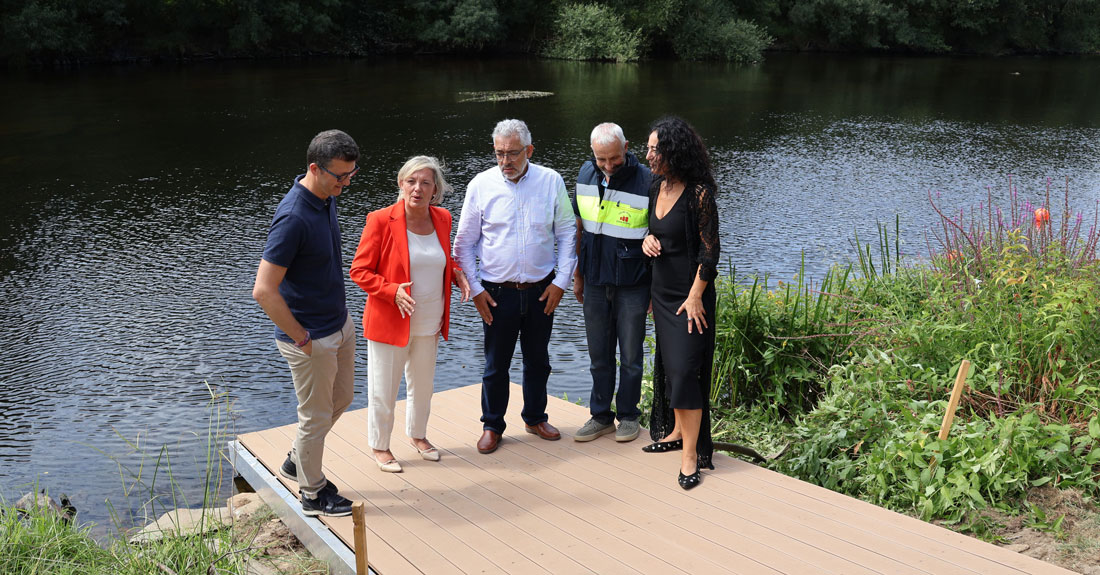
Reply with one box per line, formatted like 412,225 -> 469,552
0,55 -> 1100,532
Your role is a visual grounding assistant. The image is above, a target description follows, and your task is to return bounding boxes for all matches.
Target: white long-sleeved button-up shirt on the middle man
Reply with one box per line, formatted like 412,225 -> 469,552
454,162 -> 576,297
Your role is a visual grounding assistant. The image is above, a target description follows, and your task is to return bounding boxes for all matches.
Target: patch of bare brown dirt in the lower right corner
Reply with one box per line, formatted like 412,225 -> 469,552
979,486 -> 1100,575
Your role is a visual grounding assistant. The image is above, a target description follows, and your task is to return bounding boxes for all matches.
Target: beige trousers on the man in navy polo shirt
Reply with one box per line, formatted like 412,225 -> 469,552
275,314 -> 355,499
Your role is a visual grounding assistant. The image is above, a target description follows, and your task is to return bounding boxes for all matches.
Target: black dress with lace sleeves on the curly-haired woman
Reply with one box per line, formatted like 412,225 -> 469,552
649,178 -> 721,468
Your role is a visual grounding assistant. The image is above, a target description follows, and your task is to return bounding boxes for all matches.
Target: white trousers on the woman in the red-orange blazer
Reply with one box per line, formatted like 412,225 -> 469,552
366,334 -> 439,451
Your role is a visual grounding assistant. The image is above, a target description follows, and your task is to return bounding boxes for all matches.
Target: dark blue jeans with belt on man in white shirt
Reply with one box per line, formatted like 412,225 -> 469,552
482,280 -> 553,433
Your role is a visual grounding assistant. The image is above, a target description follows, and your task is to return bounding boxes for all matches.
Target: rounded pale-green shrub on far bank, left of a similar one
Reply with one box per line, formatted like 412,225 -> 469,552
542,3 -> 641,62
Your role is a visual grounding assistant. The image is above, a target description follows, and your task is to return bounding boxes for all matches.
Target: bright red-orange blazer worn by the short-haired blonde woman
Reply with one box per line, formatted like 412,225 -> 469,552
351,200 -> 462,346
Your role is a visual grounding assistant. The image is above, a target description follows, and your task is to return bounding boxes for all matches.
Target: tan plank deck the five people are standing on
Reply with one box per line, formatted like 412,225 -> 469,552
238,385 -> 1071,575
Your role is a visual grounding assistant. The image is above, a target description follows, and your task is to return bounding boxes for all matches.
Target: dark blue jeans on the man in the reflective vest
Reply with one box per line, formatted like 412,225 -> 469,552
584,283 -> 649,423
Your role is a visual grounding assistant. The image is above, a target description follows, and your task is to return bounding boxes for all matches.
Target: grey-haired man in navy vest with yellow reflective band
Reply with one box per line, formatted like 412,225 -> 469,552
573,122 -> 652,441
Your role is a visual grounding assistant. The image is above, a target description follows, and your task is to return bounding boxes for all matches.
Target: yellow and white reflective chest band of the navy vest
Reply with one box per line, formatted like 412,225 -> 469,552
576,183 -> 649,240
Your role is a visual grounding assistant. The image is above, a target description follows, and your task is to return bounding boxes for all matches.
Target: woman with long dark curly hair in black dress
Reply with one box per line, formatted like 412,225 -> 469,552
641,117 -> 719,489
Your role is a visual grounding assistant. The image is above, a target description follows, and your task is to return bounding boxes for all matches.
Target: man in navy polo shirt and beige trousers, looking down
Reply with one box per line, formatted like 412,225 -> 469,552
252,130 -> 359,517
